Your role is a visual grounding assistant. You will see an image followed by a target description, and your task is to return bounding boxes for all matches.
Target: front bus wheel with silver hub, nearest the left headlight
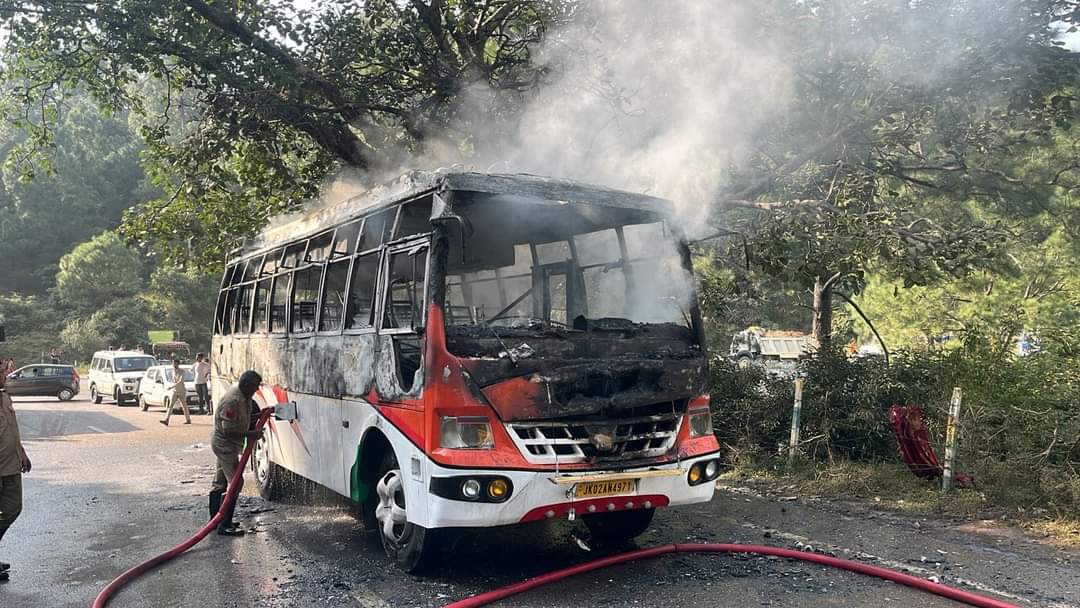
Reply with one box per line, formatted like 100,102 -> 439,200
375,451 -> 438,572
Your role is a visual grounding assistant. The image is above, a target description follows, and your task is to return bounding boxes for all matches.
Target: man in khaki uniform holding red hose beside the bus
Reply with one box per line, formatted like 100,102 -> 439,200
210,369 -> 262,537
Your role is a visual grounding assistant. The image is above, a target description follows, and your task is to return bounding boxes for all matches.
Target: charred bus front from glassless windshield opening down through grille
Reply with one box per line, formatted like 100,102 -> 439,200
436,192 -> 705,462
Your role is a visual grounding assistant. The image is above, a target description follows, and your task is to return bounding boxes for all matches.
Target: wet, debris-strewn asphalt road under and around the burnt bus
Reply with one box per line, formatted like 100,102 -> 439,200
0,395 -> 1080,608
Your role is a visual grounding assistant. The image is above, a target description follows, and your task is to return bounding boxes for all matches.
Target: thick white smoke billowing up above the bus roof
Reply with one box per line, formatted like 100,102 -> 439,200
469,0 -> 792,233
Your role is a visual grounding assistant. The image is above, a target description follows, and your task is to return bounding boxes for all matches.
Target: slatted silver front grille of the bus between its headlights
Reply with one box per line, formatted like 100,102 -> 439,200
507,411 -> 683,464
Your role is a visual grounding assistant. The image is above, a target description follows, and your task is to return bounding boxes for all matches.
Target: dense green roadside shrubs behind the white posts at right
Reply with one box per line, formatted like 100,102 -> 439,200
712,333 -> 1080,519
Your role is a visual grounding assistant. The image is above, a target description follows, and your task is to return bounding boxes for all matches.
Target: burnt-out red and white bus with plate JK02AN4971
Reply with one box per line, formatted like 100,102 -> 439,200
212,171 -> 718,570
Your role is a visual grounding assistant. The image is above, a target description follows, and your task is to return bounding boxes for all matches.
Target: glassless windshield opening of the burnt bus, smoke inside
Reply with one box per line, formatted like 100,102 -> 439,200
446,192 -> 693,332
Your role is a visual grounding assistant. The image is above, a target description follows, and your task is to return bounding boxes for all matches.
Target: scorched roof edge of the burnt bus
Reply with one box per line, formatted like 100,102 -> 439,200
240,168 -> 674,258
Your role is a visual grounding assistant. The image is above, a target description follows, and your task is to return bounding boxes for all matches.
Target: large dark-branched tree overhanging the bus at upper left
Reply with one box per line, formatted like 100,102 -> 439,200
0,0 -> 573,262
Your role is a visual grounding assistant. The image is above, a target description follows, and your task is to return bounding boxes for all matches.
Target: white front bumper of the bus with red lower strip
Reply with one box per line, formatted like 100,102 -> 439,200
419,452 -> 717,528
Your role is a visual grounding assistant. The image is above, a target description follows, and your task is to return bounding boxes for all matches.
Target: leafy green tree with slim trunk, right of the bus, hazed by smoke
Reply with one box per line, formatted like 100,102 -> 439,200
717,0 -> 1080,343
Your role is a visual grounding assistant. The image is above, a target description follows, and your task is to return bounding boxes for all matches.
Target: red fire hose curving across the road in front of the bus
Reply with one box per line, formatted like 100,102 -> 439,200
444,543 -> 1017,608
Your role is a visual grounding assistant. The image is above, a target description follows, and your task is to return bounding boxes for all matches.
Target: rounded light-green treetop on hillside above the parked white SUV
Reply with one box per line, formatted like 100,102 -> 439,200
55,232 -> 147,315
